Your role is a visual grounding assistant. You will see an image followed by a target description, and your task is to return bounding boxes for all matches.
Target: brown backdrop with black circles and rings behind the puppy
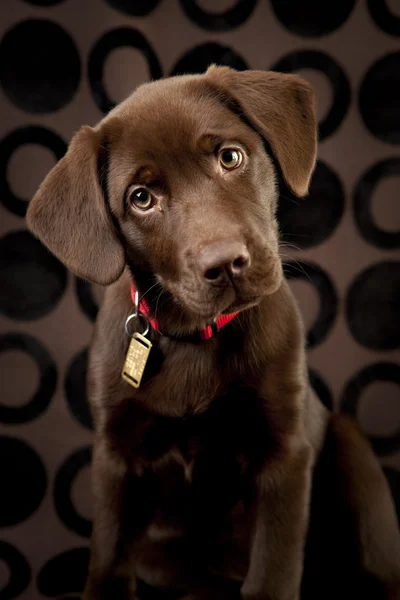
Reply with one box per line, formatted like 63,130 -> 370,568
0,0 -> 400,600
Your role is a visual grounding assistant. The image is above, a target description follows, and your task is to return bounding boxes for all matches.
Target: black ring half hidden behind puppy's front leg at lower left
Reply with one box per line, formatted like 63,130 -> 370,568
54,446 -> 92,537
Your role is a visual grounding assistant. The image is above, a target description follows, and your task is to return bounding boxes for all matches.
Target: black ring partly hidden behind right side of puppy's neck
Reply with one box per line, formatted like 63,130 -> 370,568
284,261 -> 338,348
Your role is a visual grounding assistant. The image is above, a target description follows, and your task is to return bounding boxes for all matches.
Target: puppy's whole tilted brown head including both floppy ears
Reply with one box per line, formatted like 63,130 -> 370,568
28,67 -> 316,332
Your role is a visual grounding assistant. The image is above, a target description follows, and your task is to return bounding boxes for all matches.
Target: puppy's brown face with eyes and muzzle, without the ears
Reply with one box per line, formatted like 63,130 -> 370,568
107,85 -> 282,325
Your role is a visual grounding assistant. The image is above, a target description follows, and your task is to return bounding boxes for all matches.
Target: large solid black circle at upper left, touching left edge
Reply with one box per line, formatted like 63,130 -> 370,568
0,19 -> 81,114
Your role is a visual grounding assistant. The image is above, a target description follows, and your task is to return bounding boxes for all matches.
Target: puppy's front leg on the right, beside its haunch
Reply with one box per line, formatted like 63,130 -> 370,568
242,446 -> 311,600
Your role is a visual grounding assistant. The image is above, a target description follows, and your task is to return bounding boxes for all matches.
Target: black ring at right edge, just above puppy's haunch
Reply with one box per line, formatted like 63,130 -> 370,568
340,362 -> 400,456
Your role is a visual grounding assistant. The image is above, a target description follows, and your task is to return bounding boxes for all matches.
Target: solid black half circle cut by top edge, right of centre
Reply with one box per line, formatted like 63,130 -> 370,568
272,0 -> 355,37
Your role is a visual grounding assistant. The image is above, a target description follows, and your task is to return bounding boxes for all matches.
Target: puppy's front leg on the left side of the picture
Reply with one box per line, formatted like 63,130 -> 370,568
82,439 -> 153,600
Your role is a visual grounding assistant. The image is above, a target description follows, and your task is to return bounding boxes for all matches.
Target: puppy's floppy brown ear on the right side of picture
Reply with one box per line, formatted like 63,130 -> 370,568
206,65 -> 317,196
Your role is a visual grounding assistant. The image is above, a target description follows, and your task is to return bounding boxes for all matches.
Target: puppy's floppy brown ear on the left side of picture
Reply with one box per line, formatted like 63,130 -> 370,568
27,127 -> 125,285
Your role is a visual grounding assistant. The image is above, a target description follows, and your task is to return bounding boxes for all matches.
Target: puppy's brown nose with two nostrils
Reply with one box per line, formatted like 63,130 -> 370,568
198,240 -> 250,282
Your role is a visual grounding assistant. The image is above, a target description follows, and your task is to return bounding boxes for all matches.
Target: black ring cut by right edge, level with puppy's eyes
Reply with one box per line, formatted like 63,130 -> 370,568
353,158 -> 400,250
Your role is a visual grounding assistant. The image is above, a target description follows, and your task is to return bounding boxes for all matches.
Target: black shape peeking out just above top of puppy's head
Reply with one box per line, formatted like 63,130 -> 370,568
171,42 -> 248,76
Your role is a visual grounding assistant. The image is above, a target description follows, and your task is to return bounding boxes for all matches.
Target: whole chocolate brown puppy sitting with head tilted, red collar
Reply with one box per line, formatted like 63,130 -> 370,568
28,66 -> 400,600
